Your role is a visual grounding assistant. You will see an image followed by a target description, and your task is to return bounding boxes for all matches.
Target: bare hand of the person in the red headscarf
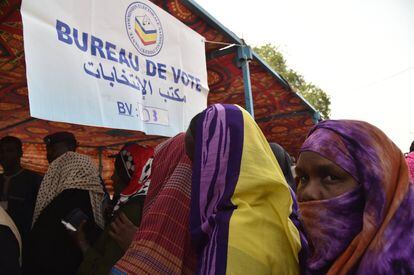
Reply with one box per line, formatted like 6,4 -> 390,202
109,212 -> 138,252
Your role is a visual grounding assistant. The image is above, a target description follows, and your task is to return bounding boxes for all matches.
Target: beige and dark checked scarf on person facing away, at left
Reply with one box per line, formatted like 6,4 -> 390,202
32,152 -> 104,228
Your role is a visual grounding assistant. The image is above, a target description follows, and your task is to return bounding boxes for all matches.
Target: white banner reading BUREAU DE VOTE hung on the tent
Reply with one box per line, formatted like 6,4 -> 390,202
22,0 -> 208,136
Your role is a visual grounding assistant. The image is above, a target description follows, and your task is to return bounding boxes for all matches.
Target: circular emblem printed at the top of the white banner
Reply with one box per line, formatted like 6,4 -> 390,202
125,2 -> 164,56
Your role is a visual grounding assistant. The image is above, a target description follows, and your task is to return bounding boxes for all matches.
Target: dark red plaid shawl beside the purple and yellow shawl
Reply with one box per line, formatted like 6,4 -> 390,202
111,134 -> 196,274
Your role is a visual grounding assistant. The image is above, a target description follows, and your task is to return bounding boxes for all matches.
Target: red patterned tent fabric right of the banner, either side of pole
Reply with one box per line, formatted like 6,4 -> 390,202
208,54 -> 314,156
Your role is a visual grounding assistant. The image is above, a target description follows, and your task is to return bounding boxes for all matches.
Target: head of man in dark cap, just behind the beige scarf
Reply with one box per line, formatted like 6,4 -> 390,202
43,132 -> 78,163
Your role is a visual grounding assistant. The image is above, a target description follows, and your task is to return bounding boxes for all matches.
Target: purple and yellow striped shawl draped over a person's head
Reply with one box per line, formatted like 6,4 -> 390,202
190,104 -> 301,274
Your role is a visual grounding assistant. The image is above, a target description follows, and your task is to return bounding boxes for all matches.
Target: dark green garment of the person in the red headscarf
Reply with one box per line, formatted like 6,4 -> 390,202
78,196 -> 145,275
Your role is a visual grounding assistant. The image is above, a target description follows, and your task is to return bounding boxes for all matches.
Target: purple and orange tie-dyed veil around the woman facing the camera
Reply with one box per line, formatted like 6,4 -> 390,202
299,120 -> 414,274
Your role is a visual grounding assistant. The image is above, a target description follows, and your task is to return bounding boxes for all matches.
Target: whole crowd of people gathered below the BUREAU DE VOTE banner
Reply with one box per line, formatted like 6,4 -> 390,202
0,104 -> 414,275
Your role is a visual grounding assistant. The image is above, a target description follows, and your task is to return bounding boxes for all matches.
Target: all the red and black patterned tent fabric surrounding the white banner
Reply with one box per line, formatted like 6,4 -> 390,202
0,0 -> 315,188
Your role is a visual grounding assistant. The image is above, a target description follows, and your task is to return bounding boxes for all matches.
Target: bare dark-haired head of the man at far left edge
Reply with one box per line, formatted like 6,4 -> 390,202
0,136 -> 23,171
